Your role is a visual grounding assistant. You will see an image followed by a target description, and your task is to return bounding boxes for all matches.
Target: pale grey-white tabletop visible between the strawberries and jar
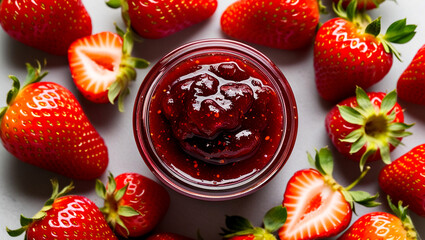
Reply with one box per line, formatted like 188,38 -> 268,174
0,0 -> 425,240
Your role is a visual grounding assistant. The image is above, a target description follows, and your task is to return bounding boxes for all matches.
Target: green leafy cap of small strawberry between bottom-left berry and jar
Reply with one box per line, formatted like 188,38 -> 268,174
95,173 -> 142,235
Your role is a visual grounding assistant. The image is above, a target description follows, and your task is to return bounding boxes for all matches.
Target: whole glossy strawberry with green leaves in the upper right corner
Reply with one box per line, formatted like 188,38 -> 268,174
313,1 -> 416,101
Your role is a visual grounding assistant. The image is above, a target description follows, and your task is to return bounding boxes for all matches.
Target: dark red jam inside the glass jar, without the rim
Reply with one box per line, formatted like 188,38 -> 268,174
149,54 -> 284,185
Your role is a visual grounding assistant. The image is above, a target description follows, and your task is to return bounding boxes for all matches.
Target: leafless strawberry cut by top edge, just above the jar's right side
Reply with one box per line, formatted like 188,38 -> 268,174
221,0 -> 320,50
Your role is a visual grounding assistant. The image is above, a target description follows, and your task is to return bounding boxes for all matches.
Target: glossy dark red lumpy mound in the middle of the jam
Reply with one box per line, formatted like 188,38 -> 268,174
161,61 -> 277,165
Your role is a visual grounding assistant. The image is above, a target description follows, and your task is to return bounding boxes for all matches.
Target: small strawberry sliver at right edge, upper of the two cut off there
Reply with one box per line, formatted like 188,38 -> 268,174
397,45 -> 425,105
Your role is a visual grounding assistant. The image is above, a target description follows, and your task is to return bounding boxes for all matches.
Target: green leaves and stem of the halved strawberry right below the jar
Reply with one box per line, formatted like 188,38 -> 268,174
307,147 -> 380,212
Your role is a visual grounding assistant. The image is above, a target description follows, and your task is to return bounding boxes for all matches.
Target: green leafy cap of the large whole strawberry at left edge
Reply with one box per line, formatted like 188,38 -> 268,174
0,61 -> 47,119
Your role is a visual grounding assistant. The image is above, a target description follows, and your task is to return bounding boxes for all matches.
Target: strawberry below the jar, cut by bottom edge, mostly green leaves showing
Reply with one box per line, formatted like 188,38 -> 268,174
221,205 -> 287,240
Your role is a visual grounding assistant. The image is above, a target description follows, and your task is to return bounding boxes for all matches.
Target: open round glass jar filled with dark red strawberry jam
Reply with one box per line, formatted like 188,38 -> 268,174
133,39 -> 298,200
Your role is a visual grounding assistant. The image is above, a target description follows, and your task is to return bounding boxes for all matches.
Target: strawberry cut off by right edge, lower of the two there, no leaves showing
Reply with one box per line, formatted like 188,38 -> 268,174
379,144 -> 425,217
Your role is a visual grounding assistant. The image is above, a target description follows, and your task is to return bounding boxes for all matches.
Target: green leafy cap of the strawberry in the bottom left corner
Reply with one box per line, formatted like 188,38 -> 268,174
6,179 -> 74,237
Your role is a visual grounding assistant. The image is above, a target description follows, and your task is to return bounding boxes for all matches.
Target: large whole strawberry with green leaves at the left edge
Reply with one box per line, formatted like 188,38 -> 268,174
0,64 -> 108,179
